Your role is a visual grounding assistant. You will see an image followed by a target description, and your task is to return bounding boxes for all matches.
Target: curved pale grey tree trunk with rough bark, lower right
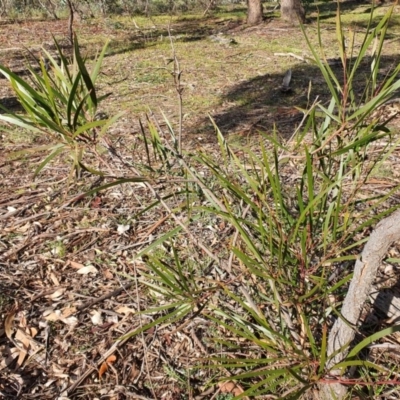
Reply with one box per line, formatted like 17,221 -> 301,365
321,210 -> 400,400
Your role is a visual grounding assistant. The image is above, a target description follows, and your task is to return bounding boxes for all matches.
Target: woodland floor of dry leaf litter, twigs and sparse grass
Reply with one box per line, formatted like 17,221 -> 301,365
0,4 -> 400,400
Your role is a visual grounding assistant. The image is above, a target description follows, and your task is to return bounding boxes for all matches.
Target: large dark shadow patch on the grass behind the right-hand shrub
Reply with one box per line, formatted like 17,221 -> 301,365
201,55 -> 400,138
